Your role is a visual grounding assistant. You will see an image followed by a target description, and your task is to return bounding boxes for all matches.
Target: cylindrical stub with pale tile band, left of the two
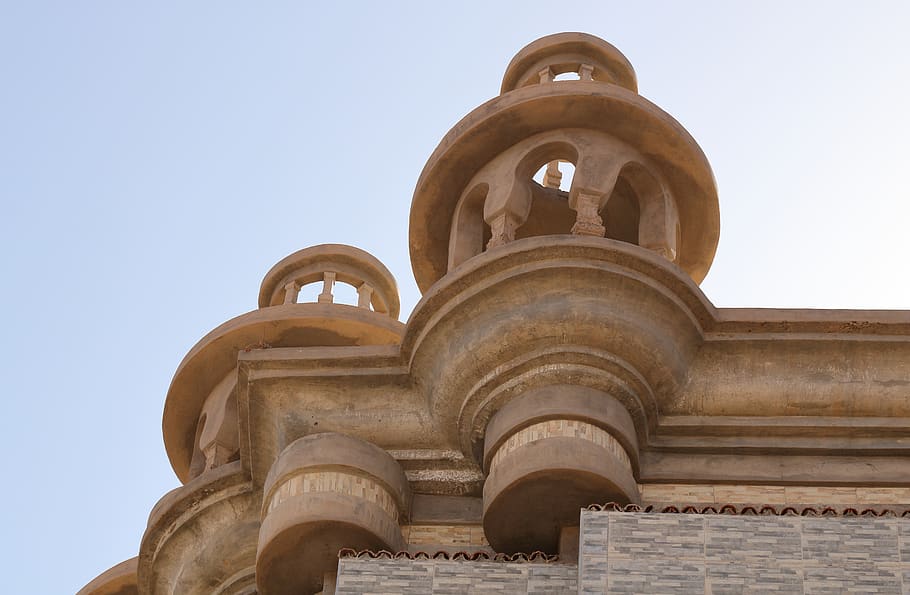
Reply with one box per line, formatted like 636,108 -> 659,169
256,433 -> 411,595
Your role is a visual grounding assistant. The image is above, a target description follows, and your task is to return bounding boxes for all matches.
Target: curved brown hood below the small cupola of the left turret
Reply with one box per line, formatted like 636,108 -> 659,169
162,304 -> 404,483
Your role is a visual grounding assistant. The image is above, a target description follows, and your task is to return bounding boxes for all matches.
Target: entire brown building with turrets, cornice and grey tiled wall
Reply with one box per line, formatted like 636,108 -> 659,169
81,33 -> 910,595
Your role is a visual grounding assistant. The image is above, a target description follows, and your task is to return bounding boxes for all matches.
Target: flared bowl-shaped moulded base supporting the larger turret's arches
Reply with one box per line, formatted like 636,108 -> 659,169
402,235 -> 714,456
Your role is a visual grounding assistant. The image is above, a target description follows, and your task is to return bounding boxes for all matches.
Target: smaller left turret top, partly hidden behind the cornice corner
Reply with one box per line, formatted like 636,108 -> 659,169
162,244 -> 404,483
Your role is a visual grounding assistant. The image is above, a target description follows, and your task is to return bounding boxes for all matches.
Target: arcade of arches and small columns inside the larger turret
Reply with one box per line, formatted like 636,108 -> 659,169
448,129 -> 679,270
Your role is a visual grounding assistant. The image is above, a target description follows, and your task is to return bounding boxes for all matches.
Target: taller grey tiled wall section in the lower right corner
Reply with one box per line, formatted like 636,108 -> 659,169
578,511 -> 910,595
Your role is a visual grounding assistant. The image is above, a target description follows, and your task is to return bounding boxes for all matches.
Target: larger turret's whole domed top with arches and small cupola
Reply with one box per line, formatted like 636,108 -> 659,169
409,33 -> 720,292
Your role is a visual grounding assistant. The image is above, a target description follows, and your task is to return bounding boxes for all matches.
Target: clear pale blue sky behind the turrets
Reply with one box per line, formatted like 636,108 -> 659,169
0,0 -> 910,594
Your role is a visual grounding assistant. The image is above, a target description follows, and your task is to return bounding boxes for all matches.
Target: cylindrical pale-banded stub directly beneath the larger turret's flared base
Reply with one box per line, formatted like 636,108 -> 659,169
483,385 -> 639,552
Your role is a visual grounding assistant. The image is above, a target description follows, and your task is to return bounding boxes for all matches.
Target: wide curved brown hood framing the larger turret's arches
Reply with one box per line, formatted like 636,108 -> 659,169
409,81 -> 720,292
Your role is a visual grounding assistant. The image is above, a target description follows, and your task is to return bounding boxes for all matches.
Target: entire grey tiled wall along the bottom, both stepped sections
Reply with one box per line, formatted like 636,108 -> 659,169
336,511 -> 910,595
